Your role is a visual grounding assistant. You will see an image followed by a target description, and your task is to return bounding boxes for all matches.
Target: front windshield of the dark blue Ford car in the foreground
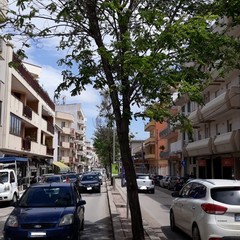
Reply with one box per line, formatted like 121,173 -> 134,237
19,186 -> 74,207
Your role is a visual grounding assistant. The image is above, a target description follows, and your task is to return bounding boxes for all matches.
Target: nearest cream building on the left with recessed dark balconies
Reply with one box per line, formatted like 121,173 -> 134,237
0,39 -> 55,176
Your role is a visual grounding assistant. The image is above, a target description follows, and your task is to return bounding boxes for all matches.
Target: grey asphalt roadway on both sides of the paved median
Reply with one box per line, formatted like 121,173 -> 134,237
0,179 -> 190,240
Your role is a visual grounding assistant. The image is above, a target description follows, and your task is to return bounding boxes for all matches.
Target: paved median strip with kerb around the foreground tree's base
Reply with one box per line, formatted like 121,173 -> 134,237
106,179 -> 166,240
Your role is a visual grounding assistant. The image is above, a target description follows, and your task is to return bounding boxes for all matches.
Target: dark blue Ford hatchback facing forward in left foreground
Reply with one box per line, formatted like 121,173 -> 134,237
4,183 -> 86,240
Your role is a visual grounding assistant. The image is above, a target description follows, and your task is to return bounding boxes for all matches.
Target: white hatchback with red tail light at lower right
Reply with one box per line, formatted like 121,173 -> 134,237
170,179 -> 240,240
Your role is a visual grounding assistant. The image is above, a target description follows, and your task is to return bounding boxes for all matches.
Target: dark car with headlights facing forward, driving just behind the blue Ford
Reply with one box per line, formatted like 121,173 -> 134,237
79,173 -> 101,193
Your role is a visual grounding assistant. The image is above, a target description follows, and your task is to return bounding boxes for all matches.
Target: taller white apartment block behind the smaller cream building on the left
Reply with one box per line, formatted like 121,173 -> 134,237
56,103 -> 87,172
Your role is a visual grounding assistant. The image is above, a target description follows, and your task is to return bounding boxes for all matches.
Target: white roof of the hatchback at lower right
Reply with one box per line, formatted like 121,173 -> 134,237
190,179 -> 240,188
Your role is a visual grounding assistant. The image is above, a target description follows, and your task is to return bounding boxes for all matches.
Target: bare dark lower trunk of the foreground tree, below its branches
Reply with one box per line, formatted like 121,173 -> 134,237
117,119 -> 144,240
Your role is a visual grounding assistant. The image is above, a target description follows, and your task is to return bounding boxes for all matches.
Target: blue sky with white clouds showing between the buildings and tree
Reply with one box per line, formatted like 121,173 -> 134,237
15,39 -> 149,141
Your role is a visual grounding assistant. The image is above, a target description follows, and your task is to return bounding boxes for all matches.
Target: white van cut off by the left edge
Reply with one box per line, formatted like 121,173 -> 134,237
0,169 -> 19,203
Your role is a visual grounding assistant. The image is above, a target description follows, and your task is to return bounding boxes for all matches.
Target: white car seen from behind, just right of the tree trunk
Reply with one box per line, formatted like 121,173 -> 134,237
136,173 -> 155,193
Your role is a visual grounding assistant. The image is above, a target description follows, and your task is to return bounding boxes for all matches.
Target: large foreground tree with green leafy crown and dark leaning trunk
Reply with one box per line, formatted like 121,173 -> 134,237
2,0 -> 240,240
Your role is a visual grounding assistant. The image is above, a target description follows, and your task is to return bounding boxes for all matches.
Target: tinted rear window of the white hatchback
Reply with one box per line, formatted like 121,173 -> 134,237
211,187 -> 240,205
